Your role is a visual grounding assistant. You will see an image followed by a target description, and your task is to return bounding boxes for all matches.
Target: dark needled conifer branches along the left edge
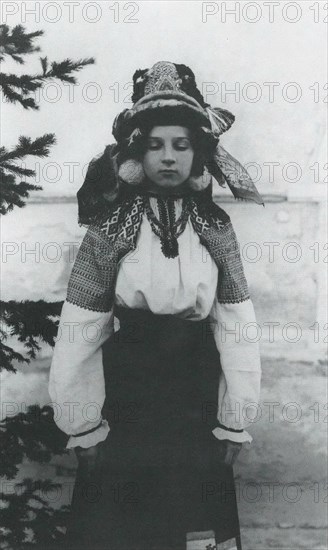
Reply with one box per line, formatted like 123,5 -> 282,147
0,25 -> 94,550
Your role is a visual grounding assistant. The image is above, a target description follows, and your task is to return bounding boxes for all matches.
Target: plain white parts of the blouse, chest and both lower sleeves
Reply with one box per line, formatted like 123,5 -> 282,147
49,197 -> 261,448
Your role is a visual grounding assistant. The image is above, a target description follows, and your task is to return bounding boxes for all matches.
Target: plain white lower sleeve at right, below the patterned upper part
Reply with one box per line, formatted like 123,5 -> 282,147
210,298 -> 261,443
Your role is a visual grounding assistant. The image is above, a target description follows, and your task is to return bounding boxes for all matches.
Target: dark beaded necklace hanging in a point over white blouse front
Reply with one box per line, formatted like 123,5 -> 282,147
145,197 -> 191,258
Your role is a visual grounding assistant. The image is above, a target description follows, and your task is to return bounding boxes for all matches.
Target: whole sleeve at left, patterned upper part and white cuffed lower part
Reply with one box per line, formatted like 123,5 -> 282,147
49,226 -> 115,448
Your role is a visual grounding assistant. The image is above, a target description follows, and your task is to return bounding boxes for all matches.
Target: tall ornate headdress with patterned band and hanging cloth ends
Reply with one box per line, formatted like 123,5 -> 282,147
77,61 -> 264,224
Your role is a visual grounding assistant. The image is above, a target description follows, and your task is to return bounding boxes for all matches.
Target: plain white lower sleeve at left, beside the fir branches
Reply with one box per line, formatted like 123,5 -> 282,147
49,300 -> 114,449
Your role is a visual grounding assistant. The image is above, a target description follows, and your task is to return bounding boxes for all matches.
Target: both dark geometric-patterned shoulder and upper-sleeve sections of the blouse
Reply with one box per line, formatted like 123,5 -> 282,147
66,195 -> 249,312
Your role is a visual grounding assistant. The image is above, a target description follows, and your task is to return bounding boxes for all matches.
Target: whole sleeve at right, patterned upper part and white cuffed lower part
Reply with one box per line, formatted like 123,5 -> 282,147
202,218 -> 261,443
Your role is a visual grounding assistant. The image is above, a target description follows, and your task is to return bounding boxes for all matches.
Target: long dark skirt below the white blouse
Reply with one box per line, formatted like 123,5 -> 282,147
66,307 -> 240,550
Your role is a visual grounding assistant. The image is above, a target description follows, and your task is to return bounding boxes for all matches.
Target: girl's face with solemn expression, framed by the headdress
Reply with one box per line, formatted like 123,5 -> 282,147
143,126 -> 194,188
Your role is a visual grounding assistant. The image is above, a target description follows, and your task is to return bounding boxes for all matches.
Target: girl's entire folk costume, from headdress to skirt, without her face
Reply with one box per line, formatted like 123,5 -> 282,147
49,61 -> 262,550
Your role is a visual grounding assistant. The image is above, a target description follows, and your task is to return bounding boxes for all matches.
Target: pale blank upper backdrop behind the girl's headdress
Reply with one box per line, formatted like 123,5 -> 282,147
2,0 -> 328,196
